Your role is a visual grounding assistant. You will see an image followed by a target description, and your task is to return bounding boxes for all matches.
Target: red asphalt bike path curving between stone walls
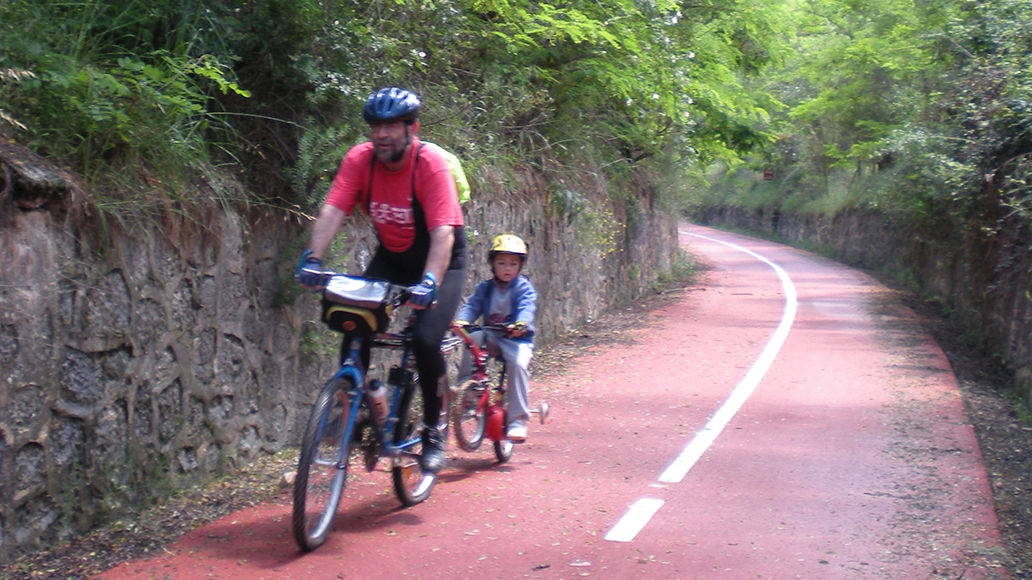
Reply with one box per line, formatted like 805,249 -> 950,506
97,225 -> 1009,580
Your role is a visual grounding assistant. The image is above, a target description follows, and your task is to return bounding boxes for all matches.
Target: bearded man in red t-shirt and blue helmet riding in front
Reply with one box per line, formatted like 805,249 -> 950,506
297,87 -> 469,473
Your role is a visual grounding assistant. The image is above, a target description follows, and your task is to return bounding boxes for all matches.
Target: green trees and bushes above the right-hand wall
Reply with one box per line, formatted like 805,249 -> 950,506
696,0 -> 1032,235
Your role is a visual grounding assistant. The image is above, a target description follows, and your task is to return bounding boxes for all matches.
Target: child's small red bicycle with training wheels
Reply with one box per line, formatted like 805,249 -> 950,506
446,324 -> 548,463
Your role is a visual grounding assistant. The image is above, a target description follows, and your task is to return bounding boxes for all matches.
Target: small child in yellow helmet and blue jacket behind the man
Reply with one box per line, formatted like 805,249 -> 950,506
455,234 -> 538,443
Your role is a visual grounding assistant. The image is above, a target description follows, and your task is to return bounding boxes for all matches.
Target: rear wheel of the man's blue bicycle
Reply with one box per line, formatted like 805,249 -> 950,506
391,384 -> 438,506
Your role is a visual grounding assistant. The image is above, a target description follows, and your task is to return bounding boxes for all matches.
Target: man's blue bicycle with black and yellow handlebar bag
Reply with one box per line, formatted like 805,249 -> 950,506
291,272 -> 435,552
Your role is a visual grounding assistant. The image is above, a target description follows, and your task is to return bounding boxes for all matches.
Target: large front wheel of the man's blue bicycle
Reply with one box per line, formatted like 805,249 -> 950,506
291,379 -> 354,552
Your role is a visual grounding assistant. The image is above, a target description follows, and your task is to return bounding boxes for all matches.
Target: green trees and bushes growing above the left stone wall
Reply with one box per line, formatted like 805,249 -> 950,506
0,0 -> 787,223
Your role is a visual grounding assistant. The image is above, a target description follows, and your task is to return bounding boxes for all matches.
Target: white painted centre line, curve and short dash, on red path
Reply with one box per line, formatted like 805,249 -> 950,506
606,233 -> 798,542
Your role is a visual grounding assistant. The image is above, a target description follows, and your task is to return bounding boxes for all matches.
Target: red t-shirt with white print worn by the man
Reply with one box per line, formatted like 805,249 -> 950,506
326,137 -> 463,252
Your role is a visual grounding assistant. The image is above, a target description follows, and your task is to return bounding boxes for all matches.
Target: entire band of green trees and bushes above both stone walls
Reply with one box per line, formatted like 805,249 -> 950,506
6,0 -> 1032,321
